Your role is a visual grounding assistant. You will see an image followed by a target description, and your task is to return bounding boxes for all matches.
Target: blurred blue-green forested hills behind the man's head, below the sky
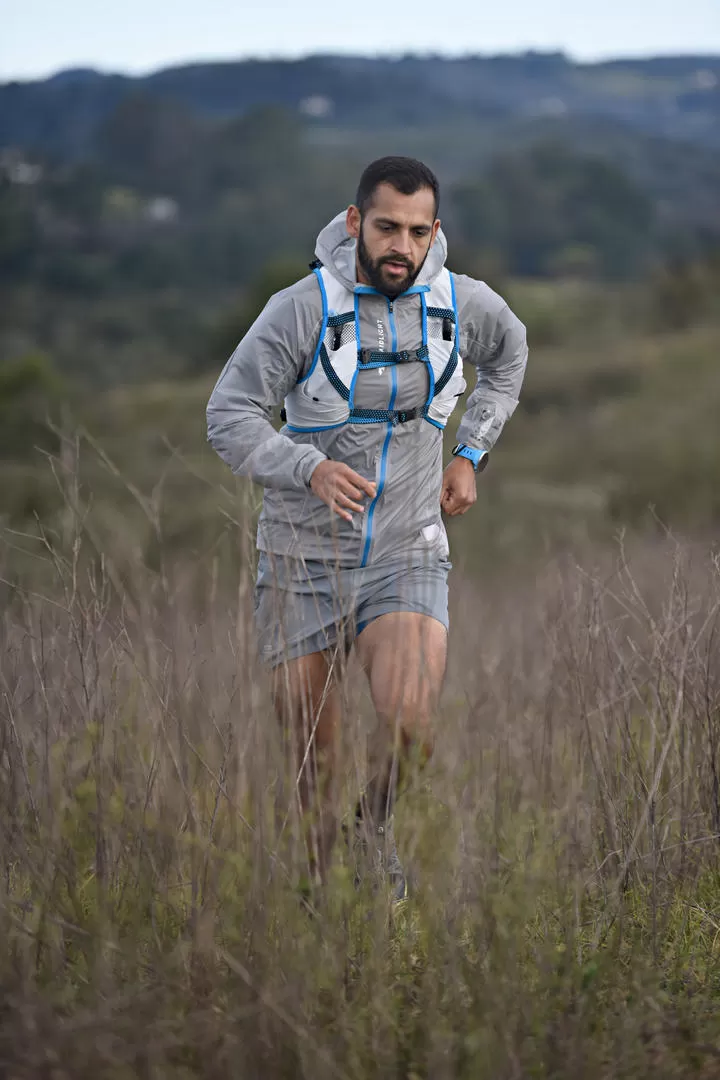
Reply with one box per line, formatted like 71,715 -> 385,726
0,54 -> 720,395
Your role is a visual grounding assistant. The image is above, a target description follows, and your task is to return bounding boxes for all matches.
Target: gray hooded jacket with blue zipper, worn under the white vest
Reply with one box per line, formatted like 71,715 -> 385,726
207,213 -> 528,566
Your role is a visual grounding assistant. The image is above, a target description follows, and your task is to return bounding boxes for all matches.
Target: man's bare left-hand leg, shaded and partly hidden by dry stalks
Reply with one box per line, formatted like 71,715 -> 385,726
273,652 -> 340,877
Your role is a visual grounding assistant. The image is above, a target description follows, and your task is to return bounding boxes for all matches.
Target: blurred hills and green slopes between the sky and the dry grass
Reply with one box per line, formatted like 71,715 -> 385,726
0,54 -> 720,574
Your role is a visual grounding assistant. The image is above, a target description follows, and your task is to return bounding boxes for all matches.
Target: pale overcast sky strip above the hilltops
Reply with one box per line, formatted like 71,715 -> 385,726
0,0 -> 720,81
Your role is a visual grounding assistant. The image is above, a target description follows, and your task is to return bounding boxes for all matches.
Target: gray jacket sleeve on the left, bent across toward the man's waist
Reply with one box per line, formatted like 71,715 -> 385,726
207,289 -> 325,490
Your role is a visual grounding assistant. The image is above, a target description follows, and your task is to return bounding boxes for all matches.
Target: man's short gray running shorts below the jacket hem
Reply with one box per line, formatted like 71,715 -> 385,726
255,552 -> 450,667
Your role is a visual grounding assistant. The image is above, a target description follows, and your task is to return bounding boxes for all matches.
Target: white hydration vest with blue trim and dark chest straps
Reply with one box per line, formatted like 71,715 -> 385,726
284,266 -> 466,432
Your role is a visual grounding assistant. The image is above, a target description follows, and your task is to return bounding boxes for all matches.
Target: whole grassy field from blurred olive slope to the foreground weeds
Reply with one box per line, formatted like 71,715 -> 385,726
0,297 -> 720,1080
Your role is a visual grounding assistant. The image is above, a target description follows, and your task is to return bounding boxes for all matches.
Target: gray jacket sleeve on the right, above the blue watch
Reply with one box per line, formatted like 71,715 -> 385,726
458,278 -> 528,450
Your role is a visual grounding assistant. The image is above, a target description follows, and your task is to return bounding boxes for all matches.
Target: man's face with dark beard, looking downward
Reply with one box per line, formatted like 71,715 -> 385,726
348,184 -> 440,297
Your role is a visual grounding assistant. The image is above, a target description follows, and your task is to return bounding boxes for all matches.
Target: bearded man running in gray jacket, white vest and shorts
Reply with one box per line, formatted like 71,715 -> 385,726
207,157 -> 528,901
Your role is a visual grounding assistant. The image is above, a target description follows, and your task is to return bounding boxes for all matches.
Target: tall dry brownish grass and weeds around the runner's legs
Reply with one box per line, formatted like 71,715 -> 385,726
0,457 -> 720,1080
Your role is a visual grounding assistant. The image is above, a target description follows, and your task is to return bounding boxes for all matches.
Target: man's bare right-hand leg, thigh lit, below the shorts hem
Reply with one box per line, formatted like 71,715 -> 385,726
356,611 -> 447,822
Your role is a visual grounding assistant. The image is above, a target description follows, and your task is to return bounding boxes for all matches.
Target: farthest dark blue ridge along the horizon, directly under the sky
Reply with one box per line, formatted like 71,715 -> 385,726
0,53 -> 720,158
